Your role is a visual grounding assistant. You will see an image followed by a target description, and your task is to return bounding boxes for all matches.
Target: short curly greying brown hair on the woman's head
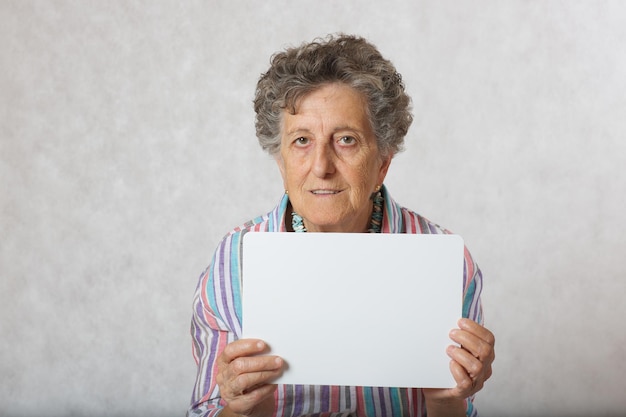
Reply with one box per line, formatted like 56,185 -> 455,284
254,34 -> 413,157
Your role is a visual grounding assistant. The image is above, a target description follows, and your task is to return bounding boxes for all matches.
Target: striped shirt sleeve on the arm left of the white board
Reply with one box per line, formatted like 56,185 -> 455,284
187,236 -> 241,417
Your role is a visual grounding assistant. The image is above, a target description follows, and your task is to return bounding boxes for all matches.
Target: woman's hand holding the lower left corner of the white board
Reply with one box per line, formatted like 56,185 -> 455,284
216,339 -> 284,416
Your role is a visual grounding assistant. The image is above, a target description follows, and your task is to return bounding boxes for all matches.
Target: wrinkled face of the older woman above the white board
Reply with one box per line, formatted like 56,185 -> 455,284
276,83 -> 391,232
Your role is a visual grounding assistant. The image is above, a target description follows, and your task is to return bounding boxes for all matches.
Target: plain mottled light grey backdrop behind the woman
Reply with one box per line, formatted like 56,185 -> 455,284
0,0 -> 626,416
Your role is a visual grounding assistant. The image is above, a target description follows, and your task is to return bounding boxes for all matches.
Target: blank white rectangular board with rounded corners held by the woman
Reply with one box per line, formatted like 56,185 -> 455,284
242,233 -> 464,388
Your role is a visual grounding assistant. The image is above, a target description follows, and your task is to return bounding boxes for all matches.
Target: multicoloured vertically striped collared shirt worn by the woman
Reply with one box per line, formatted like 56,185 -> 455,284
187,187 -> 483,417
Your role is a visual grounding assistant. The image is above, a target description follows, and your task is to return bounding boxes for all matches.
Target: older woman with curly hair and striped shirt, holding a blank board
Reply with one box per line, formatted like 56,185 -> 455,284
188,35 -> 494,417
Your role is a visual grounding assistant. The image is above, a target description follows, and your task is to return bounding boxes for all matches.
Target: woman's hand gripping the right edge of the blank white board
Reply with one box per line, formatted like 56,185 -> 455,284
423,319 -> 496,416
